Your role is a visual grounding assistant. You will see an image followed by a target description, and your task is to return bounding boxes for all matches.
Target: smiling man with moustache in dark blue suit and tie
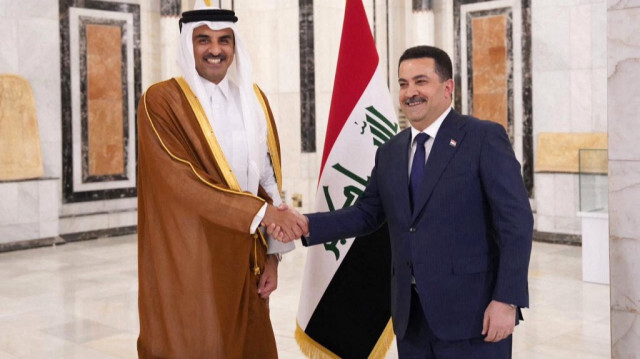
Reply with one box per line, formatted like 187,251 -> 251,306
270,46 -> 533,359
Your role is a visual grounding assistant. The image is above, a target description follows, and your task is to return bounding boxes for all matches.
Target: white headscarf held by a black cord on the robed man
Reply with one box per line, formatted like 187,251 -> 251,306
177,0 -> 267,194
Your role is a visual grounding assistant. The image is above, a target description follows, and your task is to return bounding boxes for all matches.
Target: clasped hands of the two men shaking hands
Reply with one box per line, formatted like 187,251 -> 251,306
262,203 -> 309,243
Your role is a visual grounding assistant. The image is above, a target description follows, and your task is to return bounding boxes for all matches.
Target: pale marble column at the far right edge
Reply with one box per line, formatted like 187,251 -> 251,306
607,0 -> 640,358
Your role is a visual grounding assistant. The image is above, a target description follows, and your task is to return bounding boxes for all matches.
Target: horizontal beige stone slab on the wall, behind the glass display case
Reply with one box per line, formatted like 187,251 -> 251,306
535,133 -> 608,173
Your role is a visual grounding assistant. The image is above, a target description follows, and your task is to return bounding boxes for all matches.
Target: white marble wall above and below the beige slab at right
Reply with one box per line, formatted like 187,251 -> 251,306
531,0 -> 607,235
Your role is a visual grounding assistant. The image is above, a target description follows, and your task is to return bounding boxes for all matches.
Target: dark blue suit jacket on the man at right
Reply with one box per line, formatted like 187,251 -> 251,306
303,110 -> 533,340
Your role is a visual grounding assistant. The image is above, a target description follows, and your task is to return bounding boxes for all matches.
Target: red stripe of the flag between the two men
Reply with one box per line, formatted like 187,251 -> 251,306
318,0 -> 378,180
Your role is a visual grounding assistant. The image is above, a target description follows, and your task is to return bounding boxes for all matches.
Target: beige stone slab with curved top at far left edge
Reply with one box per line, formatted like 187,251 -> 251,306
0,74 -> 43,180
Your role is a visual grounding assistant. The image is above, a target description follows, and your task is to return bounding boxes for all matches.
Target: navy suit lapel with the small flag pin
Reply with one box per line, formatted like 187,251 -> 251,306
412,109 -> 465,222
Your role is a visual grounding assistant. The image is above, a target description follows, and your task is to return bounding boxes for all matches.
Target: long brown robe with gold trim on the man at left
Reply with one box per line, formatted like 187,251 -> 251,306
138,79 -> 281,359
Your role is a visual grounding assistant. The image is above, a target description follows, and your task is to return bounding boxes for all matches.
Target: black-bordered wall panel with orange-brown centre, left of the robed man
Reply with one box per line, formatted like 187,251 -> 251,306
59,0 -> 142,203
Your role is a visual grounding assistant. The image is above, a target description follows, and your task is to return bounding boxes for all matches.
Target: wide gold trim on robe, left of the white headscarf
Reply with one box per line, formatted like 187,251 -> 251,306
174,77 -> 242,192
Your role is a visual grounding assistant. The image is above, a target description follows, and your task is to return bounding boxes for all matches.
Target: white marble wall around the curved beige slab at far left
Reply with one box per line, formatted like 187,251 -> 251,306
0,0 -> 62,251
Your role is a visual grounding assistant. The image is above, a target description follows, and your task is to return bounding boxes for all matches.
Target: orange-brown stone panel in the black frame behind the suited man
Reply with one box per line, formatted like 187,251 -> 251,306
471,15 -> 508,129
